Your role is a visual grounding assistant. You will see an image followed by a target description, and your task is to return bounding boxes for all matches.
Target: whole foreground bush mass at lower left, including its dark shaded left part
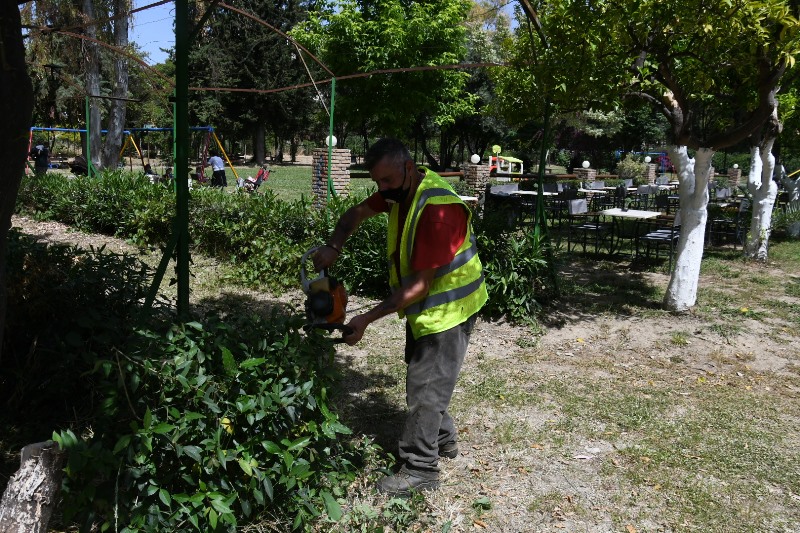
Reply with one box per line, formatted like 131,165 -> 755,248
0,232 -> 373,531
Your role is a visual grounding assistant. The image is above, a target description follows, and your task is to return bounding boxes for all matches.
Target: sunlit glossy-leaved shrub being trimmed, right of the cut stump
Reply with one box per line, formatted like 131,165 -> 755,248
54,312 -> 368,531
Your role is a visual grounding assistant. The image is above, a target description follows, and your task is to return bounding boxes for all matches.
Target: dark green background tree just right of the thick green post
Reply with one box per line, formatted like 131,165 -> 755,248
190,0 -> 318,163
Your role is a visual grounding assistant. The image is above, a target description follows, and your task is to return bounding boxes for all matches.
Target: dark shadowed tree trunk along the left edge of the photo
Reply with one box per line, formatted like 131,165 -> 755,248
0,2 -> 33,359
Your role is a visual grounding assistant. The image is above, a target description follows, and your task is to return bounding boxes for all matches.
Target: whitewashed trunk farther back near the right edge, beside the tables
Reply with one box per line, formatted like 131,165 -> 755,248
744,137 -> 778,261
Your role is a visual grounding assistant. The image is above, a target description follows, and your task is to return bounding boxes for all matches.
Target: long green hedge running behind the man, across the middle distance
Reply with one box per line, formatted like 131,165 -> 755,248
18,168 -> 546,322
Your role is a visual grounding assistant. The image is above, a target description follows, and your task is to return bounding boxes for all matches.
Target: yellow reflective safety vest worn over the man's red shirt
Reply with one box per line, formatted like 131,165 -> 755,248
387,167 -> 489,339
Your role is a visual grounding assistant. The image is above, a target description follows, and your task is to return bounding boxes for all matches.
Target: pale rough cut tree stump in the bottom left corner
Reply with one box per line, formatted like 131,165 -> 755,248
0,442 -> 64,533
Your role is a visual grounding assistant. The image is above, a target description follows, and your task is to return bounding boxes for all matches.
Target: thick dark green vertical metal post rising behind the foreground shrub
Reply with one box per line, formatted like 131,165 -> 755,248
175,0 -> 189,320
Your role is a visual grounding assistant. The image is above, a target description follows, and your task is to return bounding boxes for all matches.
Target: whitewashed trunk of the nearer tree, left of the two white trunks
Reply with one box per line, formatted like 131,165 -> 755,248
664,146 -> 714,311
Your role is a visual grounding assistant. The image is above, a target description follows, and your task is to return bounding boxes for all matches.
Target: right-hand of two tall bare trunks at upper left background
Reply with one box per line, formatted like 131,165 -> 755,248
103,0 -> 130,168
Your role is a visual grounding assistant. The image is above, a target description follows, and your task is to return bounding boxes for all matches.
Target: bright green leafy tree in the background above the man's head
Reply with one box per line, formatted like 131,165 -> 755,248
292,0 -> 474,156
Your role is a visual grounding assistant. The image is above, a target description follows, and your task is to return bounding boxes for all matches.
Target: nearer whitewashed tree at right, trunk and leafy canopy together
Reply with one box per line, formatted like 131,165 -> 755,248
504,0 -> 799,311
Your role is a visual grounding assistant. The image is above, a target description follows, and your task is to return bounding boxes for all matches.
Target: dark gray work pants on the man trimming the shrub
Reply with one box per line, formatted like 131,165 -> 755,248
399,315 -> 475,479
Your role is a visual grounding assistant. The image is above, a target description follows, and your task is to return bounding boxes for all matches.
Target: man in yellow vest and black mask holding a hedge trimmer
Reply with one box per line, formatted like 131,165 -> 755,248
314,139 -> 487,495
